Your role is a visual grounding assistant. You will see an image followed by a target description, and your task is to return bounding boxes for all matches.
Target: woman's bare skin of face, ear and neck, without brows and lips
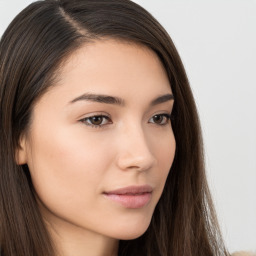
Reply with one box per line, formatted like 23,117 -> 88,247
18,39 -> 175,256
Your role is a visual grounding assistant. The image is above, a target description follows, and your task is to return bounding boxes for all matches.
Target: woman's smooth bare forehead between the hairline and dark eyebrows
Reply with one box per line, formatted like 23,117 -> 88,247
39,39 -> 171,108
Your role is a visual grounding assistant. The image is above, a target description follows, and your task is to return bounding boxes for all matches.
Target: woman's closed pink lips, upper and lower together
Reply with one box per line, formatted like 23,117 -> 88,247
103,185 -> 153,209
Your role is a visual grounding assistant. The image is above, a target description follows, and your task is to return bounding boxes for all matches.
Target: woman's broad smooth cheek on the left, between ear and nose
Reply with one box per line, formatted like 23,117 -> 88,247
28,124 -> 112,214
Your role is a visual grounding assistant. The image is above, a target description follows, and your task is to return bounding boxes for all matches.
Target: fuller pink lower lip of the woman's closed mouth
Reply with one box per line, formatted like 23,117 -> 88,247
104,193 -> 152,209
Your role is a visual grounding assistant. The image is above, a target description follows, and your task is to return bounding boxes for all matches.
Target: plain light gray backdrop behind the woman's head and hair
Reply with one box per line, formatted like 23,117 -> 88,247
0,0 -> 256,252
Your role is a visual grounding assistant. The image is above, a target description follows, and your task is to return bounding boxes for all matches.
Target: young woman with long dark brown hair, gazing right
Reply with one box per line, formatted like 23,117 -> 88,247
0,0 -> 231,256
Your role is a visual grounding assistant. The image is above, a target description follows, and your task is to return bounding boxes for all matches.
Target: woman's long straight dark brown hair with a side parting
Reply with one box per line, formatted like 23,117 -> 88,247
0,0 -> 228,256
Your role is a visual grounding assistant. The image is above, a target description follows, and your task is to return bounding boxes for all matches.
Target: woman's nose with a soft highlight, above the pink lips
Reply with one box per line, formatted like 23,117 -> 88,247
116,125 -> 156,171
